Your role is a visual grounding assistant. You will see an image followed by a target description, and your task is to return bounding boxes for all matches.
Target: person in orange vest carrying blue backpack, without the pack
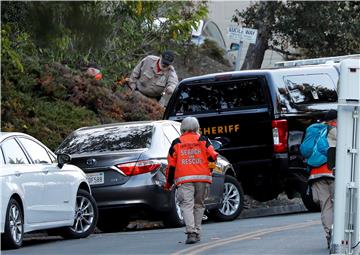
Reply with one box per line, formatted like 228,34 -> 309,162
309,110 -> 337,249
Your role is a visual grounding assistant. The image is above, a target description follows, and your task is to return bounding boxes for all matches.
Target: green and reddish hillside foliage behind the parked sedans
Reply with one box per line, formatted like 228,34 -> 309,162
1,1 -> 211,149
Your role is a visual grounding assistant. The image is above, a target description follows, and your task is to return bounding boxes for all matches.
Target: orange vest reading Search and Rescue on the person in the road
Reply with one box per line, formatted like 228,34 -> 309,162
167,132 -> 218,185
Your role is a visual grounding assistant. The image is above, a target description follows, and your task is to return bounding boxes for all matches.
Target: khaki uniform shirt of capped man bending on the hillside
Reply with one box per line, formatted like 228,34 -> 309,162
129,56 -> 179,98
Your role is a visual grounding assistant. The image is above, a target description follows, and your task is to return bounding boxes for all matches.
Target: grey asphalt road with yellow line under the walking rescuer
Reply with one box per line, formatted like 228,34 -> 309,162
2,213 -> 328,255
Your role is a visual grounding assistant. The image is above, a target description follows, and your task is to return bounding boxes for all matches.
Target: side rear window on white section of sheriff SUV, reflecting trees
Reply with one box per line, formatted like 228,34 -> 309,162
284,74 -> 337,104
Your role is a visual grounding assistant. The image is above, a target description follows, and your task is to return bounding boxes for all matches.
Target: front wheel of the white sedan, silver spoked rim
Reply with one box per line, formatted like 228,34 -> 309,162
59,190 -> 98,239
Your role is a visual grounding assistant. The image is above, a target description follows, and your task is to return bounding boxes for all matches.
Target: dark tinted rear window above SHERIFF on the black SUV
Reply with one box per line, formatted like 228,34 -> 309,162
175,79 -> 266,114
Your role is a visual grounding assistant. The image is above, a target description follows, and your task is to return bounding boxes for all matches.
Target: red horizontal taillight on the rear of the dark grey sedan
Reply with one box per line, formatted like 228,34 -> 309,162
116,160 -> 161,176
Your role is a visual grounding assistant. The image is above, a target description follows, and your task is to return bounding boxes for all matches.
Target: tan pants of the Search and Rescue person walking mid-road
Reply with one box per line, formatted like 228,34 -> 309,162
177,182 -> 210,234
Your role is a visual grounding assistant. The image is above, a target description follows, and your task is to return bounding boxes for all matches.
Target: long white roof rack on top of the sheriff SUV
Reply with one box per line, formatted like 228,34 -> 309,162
274,54 -> 360,68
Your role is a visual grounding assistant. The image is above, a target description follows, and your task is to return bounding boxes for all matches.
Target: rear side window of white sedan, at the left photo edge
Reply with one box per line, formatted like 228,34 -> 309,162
1,138 -> 29,164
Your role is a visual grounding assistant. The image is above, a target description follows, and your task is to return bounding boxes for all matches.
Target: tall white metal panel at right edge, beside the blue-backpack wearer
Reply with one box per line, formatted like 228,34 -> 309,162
330,59 -> 360,255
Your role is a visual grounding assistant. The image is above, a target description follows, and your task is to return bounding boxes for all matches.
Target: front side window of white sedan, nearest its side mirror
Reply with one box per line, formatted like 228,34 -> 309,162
19,137 -> 52,164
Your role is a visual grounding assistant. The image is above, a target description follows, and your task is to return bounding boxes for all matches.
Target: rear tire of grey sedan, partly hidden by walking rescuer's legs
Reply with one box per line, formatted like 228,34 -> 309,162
163,189 -> 185,228
